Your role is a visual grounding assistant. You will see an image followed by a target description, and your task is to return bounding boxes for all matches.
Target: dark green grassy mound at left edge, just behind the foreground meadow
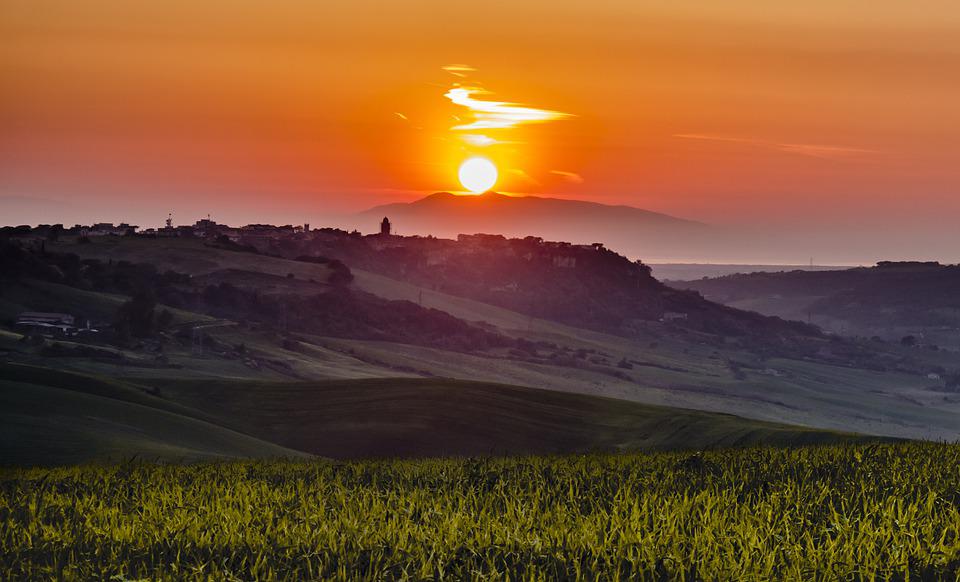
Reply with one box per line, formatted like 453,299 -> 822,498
0,365 -> 305,466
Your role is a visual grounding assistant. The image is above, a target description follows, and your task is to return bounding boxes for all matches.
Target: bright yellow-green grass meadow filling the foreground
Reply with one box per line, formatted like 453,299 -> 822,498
0,443 -> 960,580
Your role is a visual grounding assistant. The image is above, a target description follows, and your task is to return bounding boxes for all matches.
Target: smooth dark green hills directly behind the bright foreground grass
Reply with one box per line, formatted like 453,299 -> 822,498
0,364 -> 866,466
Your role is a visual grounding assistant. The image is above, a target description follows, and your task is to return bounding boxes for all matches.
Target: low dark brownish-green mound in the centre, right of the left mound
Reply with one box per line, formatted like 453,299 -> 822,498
144,378 -> 872,458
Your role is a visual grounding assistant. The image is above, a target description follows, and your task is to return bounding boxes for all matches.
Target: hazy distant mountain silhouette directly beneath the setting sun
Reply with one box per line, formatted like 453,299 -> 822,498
358,192 -> 724,260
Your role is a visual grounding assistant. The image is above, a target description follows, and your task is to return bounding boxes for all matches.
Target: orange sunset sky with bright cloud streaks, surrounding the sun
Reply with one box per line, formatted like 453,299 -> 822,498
0,0 -> 960,260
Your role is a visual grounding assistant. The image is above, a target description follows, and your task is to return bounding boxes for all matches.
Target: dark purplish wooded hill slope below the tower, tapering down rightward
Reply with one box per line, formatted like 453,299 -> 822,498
293,233 -> 820,355
